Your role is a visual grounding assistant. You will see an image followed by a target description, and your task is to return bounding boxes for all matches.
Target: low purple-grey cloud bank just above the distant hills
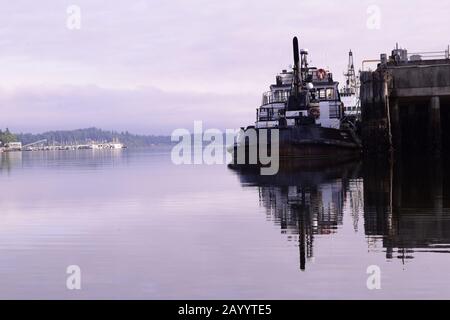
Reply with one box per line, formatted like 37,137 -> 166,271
0,86 -> 256,134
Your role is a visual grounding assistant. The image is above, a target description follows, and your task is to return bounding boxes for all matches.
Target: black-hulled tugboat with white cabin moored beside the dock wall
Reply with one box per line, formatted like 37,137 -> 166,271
228,37 -> 361,165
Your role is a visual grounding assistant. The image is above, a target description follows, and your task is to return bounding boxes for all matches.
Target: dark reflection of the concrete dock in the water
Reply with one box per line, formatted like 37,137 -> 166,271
364,157 -> 450,259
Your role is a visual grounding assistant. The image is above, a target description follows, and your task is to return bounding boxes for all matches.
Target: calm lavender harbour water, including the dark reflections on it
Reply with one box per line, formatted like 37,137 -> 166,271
0,150 -> 450,299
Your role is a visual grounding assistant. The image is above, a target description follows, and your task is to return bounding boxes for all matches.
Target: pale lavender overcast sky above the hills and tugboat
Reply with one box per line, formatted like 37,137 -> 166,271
0,0 -> 450,134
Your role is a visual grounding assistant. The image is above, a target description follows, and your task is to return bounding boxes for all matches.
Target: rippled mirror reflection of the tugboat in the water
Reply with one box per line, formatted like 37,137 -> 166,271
229,161 -> 362,270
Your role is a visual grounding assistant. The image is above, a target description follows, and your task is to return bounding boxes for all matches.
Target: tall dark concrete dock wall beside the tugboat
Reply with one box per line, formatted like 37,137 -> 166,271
360,59 -> 450,153
